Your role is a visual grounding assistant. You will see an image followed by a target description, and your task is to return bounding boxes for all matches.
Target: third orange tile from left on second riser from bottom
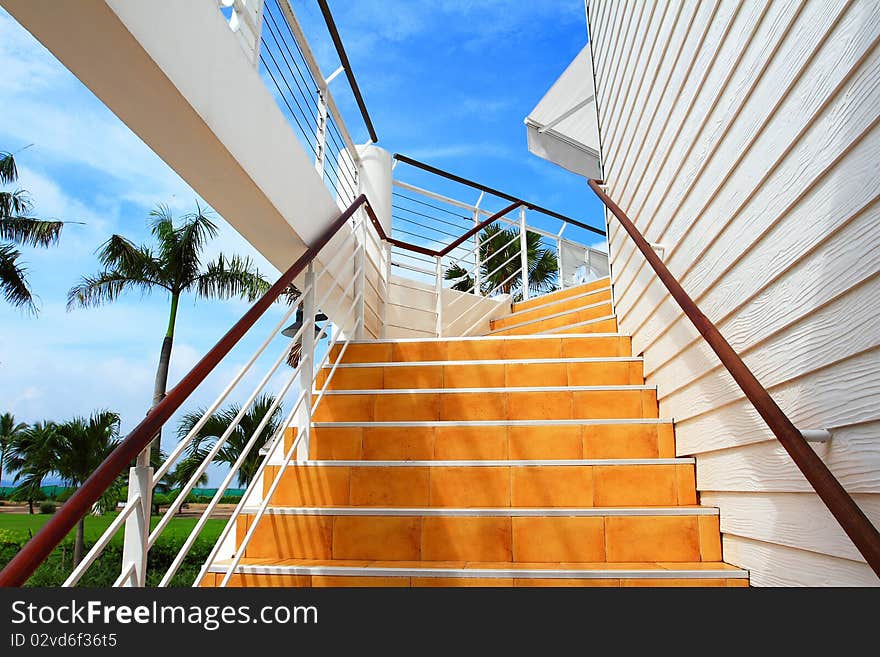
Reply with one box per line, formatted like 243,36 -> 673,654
422,516 -> 511,561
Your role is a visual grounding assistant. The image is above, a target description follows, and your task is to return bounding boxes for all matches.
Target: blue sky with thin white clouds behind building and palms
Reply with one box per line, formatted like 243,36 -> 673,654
0,0 -> 601,480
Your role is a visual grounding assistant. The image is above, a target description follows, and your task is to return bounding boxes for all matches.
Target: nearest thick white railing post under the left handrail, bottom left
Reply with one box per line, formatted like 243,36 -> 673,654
121,445 -> 153,586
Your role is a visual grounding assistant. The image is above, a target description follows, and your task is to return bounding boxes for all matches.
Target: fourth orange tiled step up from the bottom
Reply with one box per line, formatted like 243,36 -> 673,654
302,419 -> 675,461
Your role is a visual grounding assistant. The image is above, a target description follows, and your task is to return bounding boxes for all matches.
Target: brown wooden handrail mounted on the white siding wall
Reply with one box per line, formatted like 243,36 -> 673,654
589,180 -> 880,576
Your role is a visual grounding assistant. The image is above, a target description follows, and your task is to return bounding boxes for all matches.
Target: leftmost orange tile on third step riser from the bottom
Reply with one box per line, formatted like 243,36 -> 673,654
263,464 -> 351,506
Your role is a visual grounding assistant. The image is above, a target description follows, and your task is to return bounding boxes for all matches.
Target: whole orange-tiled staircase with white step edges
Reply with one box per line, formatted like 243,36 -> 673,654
201,279 -> 748,586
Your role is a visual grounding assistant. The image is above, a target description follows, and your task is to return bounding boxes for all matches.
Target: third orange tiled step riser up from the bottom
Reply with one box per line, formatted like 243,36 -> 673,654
264,464 -> 697,508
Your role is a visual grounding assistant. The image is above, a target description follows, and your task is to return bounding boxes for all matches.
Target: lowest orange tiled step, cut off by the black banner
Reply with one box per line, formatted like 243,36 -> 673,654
201,558 -> 749,587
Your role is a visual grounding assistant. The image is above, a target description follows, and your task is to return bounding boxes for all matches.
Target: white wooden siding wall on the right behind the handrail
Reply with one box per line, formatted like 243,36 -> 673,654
588,0 -> 880,585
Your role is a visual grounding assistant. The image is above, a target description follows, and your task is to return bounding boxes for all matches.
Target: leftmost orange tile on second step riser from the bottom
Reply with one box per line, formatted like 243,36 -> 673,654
238,514 -> 333,559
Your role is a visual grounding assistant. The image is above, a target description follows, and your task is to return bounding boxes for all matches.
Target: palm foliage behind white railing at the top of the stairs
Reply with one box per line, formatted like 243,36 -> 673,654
444,222 -> 558,300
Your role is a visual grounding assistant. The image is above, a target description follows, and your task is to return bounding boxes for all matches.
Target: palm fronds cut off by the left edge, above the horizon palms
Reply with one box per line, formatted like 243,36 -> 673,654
0,151 -> 64,314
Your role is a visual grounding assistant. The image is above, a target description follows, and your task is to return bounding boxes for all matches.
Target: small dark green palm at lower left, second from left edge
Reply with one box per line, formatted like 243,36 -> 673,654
9,422 -> 58,515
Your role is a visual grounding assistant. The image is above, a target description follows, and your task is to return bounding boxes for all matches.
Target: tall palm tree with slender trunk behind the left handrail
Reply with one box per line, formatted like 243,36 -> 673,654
67,205 -> 269,460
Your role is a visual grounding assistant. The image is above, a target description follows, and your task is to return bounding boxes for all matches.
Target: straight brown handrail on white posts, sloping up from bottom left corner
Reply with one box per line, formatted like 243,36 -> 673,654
0,194 -> 369,586
